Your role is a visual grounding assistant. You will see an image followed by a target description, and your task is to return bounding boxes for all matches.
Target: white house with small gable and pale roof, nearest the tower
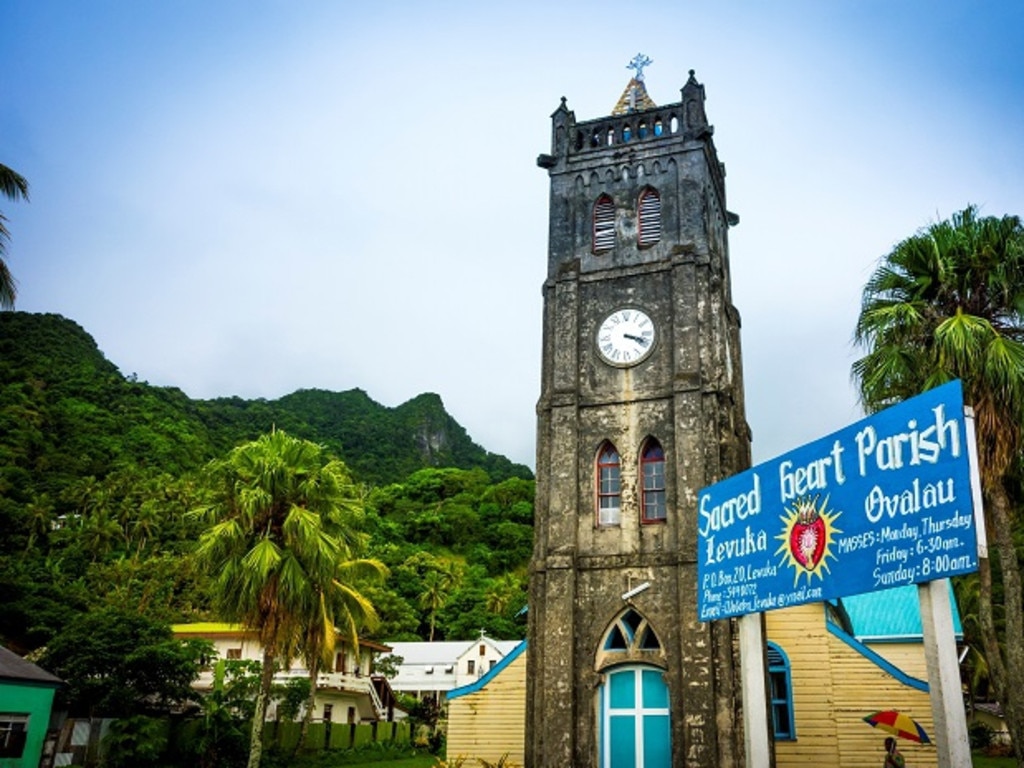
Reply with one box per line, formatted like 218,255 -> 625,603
380,633 -> 521,703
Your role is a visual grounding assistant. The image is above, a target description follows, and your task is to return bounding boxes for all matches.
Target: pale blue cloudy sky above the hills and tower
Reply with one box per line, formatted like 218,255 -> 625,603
0,0 -> 1024,465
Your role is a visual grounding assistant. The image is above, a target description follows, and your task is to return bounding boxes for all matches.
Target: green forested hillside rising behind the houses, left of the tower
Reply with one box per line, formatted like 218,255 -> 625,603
0,312 -> 534,651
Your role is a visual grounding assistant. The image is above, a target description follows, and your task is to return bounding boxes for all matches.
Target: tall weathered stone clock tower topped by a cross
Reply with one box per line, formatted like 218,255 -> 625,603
526,64 -> 750,768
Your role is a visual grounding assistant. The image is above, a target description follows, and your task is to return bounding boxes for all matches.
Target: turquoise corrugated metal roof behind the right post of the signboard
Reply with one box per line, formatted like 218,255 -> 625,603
843,584 -> 964,642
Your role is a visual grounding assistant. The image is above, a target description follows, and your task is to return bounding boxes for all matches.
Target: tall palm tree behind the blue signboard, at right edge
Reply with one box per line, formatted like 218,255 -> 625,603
853,207 -> 1024,768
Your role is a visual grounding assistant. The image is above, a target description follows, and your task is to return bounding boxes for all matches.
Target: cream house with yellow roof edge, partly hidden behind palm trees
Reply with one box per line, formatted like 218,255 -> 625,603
171,622 -> 394,723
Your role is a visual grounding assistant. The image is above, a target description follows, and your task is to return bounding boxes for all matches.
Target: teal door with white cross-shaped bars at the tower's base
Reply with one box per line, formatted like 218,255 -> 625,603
601,666 -> 672,768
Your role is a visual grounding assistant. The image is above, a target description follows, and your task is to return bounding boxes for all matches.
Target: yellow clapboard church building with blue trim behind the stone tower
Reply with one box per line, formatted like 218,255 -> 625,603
447,586 -> 959,768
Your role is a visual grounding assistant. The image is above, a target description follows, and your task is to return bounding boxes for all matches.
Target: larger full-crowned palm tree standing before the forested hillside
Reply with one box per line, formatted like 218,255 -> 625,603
196,431 -> 380,768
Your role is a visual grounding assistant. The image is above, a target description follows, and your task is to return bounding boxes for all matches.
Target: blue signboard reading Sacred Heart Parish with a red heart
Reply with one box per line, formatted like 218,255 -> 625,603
697,381 -> 978,622
